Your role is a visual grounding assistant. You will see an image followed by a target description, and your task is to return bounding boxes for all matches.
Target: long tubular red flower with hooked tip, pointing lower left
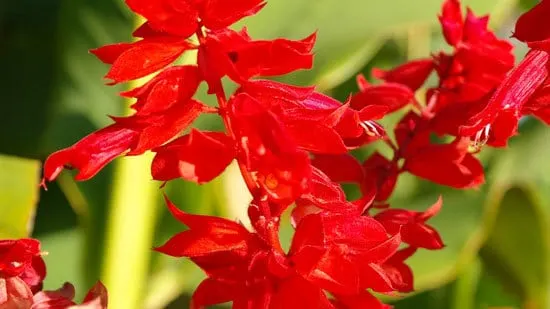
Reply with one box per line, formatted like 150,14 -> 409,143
44,96 -> 205,181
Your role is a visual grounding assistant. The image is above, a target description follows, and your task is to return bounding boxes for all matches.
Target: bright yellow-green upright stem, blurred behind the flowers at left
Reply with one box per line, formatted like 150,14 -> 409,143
101,19 -> 159,309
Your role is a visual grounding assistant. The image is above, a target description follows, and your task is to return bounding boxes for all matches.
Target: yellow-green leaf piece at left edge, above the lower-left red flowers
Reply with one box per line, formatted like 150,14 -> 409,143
0,155 -> 40,239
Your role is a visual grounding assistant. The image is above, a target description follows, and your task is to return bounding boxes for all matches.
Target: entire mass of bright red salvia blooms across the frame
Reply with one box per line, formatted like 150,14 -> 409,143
4,0 -> 550,309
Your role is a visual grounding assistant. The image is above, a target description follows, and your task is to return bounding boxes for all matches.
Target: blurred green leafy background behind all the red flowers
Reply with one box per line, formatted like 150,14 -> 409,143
0,0 -> 550,309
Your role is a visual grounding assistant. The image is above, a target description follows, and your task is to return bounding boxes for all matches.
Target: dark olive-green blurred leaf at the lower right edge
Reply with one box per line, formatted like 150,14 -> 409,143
480,187 -> 550,309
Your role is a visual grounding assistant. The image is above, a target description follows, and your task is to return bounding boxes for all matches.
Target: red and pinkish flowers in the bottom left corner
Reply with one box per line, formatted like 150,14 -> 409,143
0,238 -> 107,309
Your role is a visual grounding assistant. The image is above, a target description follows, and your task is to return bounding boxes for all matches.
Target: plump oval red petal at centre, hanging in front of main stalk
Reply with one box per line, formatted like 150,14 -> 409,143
229,93 -> 311,204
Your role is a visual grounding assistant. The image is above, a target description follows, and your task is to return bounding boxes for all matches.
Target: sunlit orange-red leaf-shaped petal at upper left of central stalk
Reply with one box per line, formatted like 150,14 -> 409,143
105,37 -> 193,84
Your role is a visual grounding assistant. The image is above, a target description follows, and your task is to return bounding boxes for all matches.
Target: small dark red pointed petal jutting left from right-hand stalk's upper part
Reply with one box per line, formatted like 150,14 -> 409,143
372,58 -> 434,91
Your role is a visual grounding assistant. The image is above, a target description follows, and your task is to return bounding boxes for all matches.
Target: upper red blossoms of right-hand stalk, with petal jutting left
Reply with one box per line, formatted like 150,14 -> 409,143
374,0 -> 514,146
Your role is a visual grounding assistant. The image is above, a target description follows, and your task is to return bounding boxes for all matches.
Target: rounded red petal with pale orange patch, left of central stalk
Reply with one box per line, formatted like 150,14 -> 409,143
151,129 -> 235,184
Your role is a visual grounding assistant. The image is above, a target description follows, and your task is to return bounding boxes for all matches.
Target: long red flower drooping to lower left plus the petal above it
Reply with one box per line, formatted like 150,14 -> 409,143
44,66 -> 207,181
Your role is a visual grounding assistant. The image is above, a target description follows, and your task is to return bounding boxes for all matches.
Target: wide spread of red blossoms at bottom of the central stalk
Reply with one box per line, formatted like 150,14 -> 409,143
156,197 -> 400,309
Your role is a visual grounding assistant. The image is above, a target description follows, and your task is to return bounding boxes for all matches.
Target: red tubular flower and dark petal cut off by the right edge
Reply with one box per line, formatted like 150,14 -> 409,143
461,1 -> 550,146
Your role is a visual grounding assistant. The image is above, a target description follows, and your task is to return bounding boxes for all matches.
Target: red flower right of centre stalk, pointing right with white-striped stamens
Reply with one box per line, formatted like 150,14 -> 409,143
240,81 -> 391,154
